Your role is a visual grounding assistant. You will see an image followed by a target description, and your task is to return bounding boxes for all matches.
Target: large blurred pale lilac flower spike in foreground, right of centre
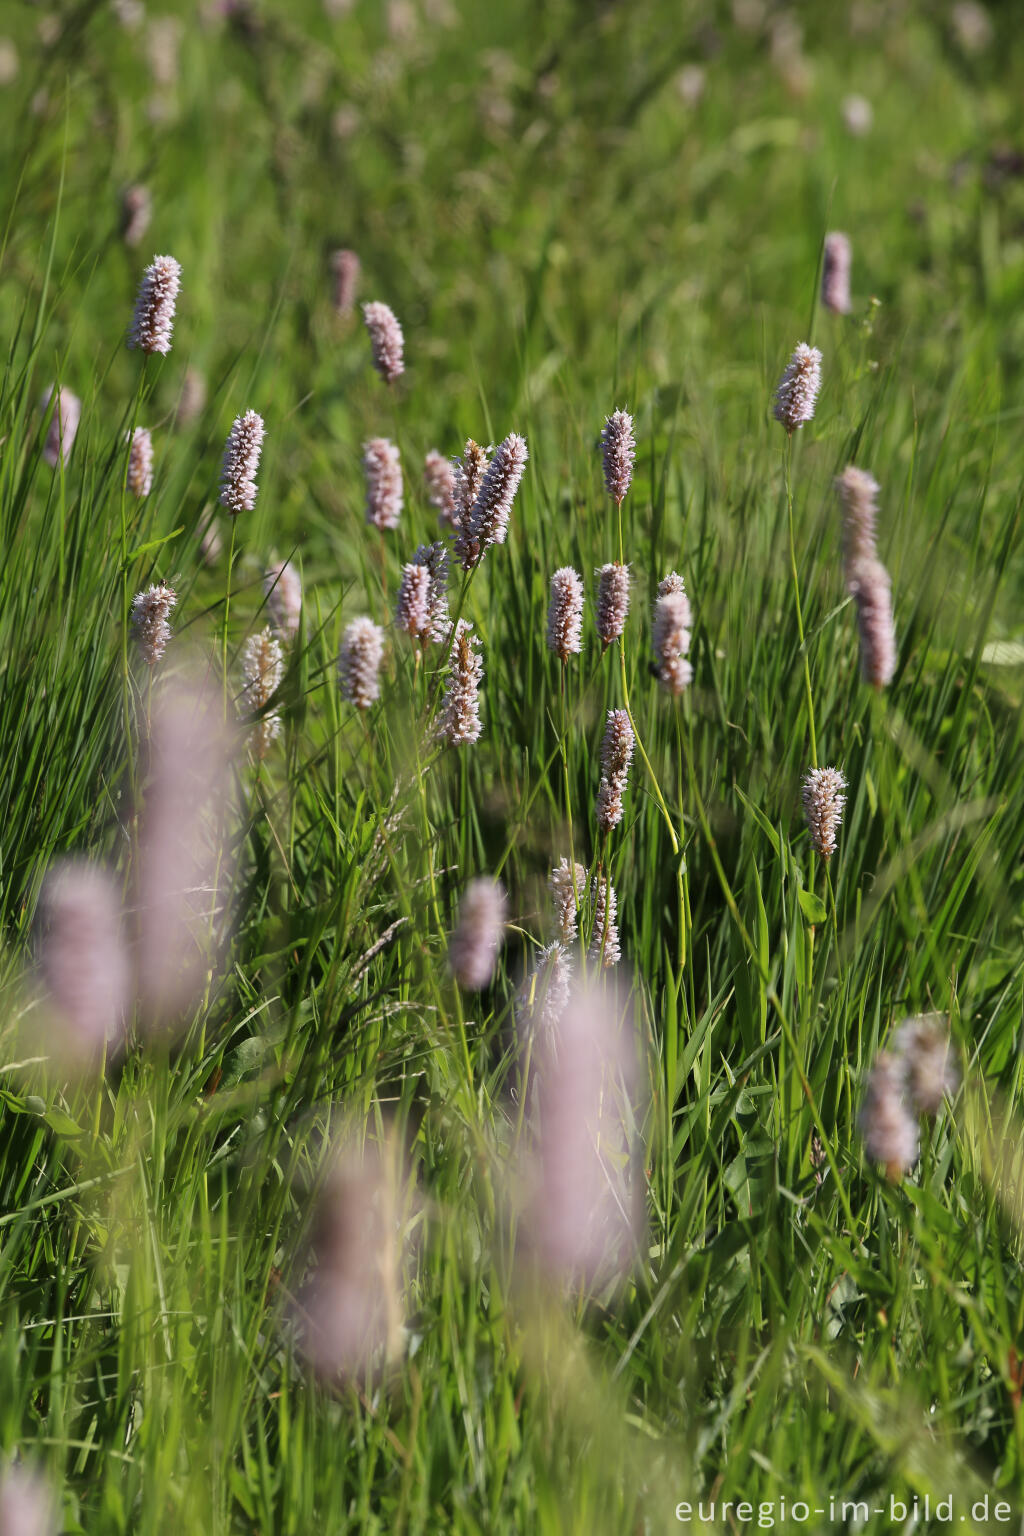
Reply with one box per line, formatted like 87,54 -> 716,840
522,983 -> 643,1286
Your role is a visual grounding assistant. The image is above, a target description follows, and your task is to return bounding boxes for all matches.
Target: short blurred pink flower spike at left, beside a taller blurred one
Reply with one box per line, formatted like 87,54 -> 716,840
38,860 -> 129,1061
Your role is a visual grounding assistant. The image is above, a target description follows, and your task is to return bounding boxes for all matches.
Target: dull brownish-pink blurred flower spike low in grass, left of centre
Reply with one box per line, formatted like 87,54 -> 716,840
295,1144 -> 408,1381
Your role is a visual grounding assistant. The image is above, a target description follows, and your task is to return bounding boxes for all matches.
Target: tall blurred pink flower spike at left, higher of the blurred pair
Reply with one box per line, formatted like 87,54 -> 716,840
135,680 -> 235,1028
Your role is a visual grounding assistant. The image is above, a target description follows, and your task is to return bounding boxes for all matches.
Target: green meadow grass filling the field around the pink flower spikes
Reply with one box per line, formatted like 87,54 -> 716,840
0,0 -> 1024,1536
